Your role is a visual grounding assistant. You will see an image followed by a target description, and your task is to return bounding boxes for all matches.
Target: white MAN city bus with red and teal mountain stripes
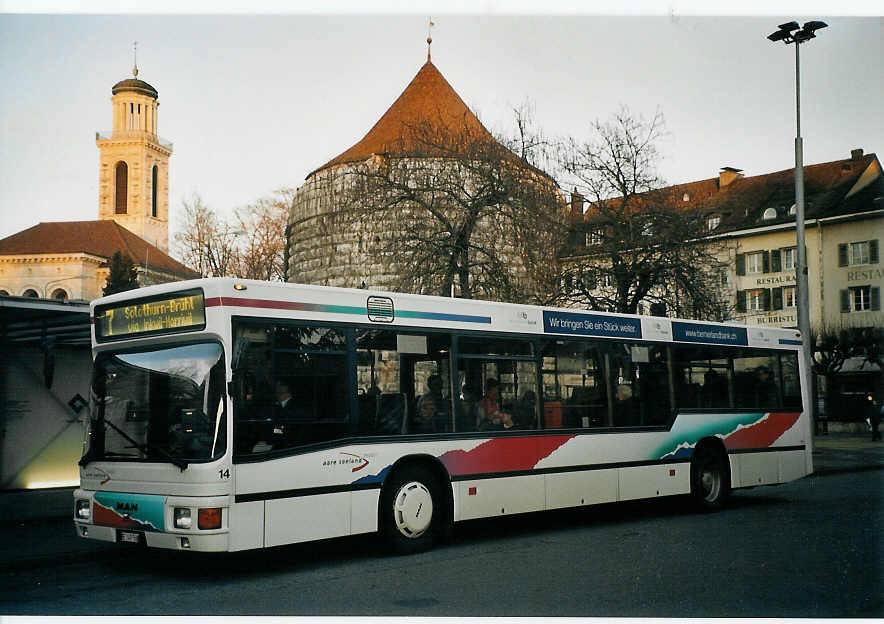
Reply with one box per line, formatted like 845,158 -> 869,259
74,279 -> 812,552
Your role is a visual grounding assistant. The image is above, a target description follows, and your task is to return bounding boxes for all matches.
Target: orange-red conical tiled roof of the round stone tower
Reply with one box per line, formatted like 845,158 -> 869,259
307,61 -> 494,178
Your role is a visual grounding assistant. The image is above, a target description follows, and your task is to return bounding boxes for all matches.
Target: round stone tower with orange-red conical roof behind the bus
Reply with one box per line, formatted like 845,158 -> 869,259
288,58 -> 545,294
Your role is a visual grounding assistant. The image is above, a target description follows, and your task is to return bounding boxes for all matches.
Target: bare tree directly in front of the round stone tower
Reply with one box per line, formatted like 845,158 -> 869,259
339,116 -> 564,303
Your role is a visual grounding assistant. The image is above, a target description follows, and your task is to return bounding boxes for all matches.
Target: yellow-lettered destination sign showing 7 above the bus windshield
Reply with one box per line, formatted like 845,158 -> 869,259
95,290 -> 206,340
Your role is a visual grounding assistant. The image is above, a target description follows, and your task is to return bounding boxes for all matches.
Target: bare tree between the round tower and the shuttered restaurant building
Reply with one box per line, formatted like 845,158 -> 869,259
561,108 -> 731,320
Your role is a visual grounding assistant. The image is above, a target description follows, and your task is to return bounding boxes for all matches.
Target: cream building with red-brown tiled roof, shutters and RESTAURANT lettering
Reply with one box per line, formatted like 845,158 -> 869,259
567,149 -> 884,418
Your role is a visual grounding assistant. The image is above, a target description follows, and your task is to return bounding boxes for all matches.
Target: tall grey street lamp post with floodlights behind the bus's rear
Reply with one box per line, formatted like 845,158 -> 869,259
767,21 -> 827,442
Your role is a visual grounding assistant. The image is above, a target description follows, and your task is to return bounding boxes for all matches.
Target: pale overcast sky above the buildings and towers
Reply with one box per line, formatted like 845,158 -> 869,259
0,0 -> 884,245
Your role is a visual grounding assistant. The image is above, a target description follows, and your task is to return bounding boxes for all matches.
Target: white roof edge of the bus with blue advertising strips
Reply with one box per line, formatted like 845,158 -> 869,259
91,278 -> 801,349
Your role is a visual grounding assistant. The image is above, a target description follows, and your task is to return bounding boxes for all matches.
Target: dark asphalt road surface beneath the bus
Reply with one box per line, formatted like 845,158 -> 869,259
0,470 -> 884,618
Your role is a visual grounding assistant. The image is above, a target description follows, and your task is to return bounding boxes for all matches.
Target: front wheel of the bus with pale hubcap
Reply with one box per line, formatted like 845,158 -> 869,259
380,465 -> 446,555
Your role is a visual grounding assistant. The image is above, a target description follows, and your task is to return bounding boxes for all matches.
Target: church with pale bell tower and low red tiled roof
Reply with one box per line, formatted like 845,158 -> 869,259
0,67 -> 199,300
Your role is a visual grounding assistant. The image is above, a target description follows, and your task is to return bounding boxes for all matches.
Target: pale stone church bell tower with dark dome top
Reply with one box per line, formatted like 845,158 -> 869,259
95,56 -> 172,252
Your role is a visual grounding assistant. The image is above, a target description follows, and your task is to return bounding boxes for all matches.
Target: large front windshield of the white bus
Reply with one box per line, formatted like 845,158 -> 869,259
80,342 -> 227,470
